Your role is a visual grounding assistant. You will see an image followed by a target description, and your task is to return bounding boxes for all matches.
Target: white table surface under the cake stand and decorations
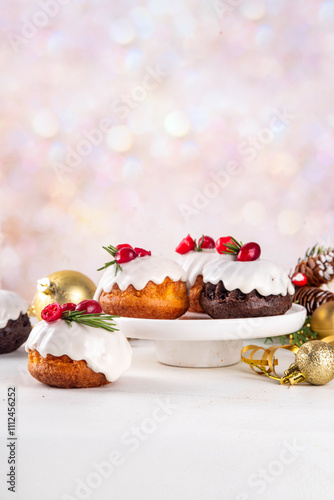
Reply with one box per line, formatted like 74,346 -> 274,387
0,340 -> 334,500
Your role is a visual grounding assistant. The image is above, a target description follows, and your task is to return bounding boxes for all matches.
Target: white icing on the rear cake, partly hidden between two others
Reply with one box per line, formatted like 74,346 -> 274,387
177,249 -> 236,288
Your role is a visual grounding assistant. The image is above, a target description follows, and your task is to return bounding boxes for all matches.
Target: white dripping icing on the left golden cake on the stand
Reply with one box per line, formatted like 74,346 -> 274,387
94,255 -> 187,300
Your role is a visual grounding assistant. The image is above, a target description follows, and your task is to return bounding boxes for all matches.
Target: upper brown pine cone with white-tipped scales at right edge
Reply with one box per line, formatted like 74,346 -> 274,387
293,246 -> 334,286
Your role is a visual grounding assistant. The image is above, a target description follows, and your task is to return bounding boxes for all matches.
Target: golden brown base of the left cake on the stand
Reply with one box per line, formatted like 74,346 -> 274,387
99,277 -> 189,319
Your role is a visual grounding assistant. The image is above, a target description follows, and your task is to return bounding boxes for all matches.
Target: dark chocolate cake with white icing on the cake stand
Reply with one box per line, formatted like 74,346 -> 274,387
199,259 -> 294,319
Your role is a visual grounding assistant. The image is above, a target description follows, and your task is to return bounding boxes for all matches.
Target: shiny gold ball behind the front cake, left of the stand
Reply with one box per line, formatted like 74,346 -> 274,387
30,271 -> 96,320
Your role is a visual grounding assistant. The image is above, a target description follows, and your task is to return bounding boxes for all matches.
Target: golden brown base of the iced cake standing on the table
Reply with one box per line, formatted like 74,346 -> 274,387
28,350 -> 110,389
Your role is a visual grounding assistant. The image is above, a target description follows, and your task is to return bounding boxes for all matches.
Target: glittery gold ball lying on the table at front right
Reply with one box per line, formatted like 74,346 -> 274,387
295,340 -> 334,385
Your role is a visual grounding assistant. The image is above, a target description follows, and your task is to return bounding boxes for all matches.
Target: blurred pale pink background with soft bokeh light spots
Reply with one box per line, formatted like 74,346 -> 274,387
0,0 -> 334,300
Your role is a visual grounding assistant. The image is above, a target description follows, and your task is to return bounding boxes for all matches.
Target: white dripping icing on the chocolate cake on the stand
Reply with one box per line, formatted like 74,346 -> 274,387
203,259 -> 294,297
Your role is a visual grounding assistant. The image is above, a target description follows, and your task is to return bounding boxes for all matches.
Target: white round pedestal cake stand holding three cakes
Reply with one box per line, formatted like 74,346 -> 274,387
116,304 -> 306,368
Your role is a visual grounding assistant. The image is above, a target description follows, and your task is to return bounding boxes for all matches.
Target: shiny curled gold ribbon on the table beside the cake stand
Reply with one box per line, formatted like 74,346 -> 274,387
241,335 -> 334,384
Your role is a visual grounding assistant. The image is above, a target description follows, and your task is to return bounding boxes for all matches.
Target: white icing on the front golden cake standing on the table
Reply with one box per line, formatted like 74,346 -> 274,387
26,319 -> 132,382
